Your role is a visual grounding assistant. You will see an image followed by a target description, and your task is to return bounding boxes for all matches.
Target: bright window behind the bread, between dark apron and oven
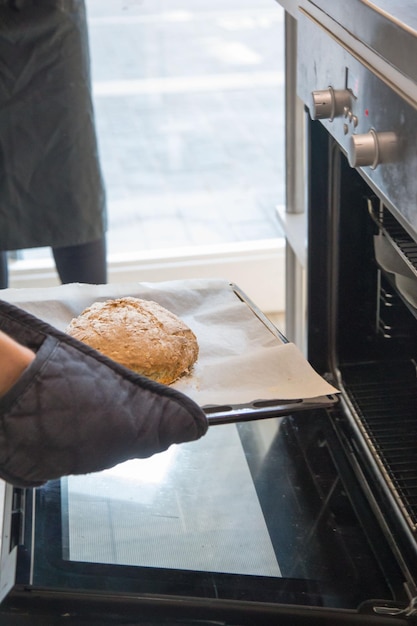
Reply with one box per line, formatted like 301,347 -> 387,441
13,0 -> 285,312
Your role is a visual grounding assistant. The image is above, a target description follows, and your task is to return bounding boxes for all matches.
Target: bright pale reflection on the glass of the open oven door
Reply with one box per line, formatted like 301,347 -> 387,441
63,424 -> 280,577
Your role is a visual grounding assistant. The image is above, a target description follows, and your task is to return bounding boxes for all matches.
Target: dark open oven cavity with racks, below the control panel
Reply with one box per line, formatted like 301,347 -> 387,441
308,122 -> 417,586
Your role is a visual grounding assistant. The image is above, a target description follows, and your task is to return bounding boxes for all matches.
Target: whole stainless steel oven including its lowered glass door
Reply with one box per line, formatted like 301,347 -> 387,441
0,2 -> 417,626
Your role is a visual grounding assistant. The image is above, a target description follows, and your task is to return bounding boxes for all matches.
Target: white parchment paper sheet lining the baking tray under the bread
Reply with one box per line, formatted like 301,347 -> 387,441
1,279 -> 337,406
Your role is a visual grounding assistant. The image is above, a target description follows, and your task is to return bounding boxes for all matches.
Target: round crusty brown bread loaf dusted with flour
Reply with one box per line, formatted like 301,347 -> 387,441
67,297 -> 198,385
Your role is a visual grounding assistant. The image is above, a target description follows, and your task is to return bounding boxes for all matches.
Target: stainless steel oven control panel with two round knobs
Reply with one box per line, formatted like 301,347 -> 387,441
297,12 -> 417,239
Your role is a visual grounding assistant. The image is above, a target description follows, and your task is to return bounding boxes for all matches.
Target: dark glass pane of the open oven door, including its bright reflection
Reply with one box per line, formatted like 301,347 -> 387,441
27,411 -> 393,608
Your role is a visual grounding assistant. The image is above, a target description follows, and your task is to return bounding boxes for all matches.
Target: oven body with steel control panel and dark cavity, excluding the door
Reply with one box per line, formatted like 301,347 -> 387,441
297,1 -> 417,614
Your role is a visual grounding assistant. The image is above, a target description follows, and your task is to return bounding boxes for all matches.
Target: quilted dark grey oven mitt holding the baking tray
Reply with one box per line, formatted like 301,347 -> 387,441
0,300 -> 208,487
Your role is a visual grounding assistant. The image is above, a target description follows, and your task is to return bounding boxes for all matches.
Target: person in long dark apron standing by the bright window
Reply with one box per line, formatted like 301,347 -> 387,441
0,0 -> 107,288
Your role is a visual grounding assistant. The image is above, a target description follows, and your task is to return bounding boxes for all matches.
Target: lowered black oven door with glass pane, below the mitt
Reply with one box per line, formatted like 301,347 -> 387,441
0,407 -> 410,626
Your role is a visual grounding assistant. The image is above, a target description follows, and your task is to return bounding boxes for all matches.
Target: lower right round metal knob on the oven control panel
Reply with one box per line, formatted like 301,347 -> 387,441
348,129 -> 398,170
